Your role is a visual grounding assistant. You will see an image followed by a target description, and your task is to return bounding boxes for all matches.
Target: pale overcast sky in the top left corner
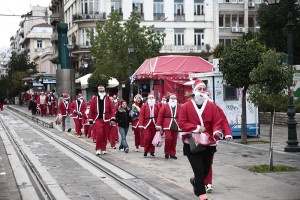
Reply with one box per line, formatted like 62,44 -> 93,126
0,0 -> 51,51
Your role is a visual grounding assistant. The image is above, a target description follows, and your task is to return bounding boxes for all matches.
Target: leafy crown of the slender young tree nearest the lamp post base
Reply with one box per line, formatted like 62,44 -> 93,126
248,50 -> 294,111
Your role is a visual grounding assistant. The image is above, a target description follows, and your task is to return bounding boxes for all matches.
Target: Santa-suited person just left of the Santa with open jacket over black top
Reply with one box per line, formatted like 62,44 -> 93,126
69,94 -> 86,138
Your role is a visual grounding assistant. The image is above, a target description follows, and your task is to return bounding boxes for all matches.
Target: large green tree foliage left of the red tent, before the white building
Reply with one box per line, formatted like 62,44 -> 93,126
89,11 -> 164,83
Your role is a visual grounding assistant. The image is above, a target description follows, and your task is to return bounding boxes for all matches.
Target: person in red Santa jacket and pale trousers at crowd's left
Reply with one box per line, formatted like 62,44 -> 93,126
57,93 -> 71,132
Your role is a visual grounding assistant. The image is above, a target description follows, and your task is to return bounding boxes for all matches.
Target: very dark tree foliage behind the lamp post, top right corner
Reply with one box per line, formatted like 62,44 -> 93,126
257,0 -> 300,64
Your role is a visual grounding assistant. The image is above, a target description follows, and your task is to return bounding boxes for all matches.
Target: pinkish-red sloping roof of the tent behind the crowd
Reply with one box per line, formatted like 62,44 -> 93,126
134,55 -> 213,80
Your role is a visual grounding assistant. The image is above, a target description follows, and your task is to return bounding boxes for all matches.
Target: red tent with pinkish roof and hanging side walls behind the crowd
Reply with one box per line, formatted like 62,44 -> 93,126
133,55 -> 213,103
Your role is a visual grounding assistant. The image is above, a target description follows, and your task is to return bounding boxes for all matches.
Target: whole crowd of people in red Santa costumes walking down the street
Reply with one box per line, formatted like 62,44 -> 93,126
12,79 -> 232,200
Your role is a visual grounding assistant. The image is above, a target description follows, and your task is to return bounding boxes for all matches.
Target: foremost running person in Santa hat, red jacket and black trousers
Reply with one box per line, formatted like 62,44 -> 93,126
178,79 -> 223,200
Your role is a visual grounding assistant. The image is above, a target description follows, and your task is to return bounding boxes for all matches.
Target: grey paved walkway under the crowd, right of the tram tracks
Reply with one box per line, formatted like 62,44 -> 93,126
0,106 -> 300,200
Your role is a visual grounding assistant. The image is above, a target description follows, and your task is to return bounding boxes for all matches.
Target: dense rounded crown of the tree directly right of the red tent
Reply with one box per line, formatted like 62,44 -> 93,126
220,39 -> 266,89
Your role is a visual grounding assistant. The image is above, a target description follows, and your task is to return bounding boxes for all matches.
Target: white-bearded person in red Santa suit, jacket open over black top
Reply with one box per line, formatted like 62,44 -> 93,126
88,85 -> 116,155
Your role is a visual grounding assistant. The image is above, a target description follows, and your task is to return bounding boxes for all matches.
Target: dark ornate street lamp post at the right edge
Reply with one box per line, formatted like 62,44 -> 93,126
267,0 -> 300,152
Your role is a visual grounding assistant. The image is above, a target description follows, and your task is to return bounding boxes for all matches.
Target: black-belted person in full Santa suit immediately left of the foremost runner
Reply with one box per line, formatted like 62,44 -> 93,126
156,93 -> 180,159
